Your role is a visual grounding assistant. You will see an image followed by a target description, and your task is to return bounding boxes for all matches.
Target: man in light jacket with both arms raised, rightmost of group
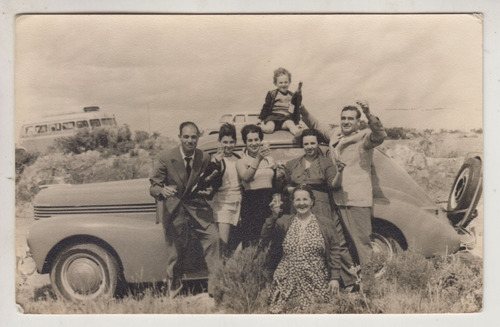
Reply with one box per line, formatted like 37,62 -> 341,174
301,102 -> 387,264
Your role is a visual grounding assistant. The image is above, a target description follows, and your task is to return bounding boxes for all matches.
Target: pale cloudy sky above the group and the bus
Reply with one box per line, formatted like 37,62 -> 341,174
15,14 -> 482,137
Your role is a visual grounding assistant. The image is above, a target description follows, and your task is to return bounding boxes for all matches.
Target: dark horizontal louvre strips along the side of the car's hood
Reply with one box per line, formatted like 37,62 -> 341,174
34,203 -> 156,219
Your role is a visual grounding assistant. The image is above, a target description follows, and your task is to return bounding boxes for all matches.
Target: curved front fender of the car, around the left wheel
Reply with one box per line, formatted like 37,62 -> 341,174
28,213 -> 167,283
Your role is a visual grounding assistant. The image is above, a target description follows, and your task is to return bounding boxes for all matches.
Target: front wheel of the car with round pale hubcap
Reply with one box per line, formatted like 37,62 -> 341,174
50,243 -> 118,301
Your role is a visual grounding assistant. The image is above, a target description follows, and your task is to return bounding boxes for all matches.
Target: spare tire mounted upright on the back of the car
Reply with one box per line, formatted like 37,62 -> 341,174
447,158 -> 482,227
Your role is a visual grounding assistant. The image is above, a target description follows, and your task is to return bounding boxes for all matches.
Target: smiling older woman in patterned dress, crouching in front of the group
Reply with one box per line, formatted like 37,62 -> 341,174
262,185 -> 341,313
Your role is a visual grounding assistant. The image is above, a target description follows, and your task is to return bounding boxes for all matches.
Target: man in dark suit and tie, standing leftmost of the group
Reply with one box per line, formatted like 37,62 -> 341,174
150,122 -> 219,297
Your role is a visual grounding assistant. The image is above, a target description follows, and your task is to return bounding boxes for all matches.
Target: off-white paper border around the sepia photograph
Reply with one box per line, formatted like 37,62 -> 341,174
0,0 -> 500,327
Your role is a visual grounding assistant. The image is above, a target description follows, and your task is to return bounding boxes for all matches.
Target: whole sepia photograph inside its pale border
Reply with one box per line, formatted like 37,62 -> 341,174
14,12 -> 484,315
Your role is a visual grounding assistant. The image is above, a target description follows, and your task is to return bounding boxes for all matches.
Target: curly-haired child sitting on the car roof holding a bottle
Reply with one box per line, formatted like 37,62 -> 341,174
258,67 -> 302,136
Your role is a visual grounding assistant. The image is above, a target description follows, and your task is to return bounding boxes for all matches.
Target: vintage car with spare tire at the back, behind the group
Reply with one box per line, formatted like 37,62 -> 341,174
23,131 -> 482,300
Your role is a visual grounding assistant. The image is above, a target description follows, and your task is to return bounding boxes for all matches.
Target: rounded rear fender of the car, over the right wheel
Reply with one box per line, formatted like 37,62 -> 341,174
373,200 -> 460,257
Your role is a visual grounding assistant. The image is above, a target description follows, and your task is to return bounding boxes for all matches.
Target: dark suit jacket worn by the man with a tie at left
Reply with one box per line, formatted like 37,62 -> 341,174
149,147 -> 214,228
